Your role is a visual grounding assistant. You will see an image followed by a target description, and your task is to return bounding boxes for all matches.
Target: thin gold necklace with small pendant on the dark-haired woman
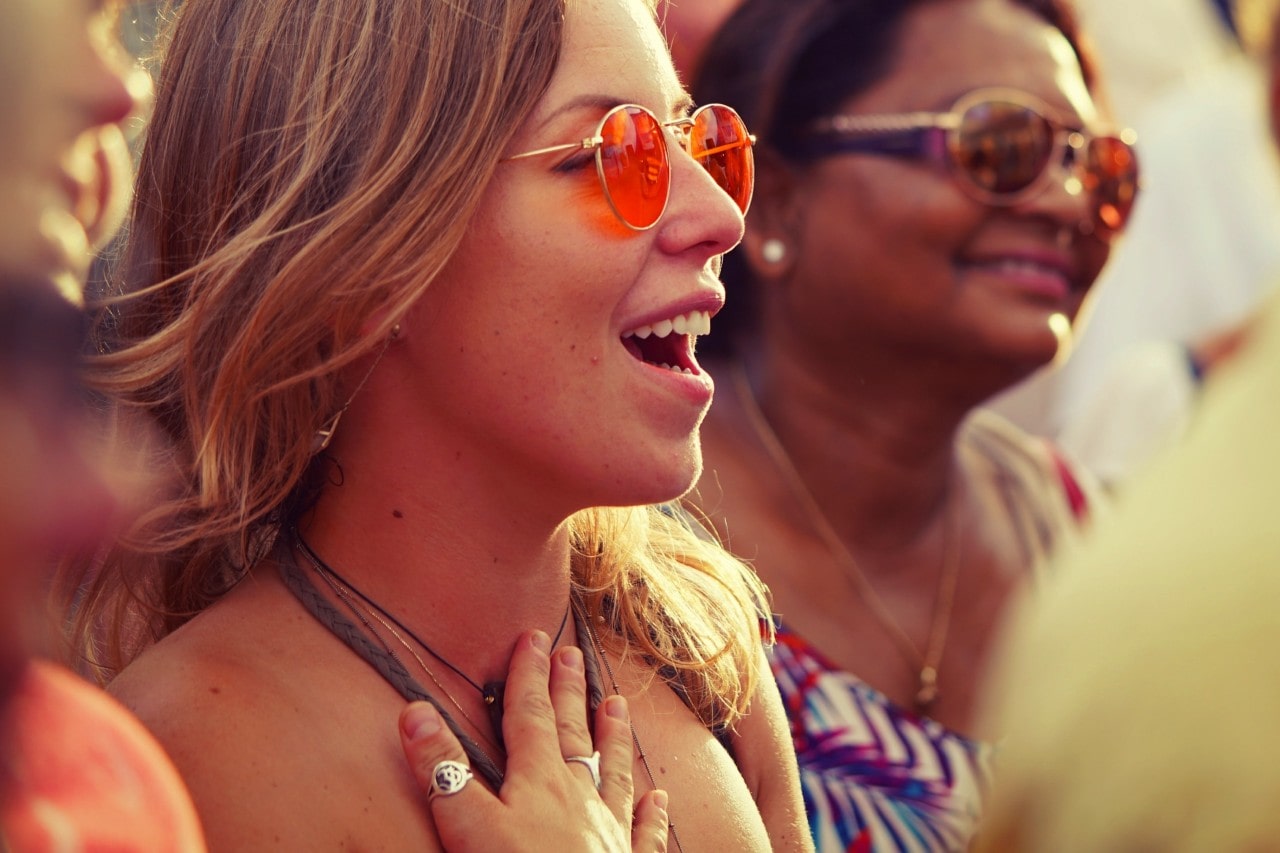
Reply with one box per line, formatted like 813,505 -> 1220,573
733,366 -> 960,712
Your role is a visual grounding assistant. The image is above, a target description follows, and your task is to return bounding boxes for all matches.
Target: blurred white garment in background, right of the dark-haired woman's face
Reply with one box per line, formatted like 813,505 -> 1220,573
992,55 -> 1280,479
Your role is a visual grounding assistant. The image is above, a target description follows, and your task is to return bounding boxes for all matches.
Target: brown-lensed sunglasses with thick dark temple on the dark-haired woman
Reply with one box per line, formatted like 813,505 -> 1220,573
804,88 -> 1138,237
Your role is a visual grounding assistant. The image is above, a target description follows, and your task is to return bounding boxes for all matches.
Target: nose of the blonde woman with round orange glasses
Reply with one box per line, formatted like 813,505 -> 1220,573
658,137 -> 745,257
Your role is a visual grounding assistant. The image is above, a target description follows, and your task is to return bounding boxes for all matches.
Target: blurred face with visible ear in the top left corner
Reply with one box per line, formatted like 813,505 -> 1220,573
0,0 -> 147,300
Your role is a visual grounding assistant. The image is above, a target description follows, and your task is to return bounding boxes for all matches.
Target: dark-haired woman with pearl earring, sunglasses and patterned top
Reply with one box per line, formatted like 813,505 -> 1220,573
694,0 -> 1137,850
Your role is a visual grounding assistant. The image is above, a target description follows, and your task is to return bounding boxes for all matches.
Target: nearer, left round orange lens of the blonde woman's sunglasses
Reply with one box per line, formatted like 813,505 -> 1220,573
598,106 -> 671,228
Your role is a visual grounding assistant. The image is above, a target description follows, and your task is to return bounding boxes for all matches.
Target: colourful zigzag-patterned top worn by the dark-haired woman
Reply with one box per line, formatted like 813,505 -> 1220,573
769,411 -> 1098,853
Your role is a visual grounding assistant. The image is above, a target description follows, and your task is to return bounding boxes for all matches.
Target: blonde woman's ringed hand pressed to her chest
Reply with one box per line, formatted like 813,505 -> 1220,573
399,631 -> 667,853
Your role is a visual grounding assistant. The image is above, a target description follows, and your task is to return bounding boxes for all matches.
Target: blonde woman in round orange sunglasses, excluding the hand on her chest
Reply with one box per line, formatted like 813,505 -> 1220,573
64,0 -> 806,850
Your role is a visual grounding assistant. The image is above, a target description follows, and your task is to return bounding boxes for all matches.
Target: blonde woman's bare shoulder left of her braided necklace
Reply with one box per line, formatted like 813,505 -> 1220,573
109,563 -> 429,850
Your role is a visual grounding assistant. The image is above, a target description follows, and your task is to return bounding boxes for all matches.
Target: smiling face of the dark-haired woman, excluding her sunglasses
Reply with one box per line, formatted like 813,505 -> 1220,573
762,0 -> 1111,381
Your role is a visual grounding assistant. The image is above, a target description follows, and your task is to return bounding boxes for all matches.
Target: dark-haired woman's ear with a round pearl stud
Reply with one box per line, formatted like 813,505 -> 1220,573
741,149 -> 804,283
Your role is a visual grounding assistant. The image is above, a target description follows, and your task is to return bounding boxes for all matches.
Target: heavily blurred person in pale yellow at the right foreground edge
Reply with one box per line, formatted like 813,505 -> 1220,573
979,0 -> 1280,853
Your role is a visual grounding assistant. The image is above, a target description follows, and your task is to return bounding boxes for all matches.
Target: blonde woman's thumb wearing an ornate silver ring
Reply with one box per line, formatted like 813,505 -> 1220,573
399,702 -> 498,849
